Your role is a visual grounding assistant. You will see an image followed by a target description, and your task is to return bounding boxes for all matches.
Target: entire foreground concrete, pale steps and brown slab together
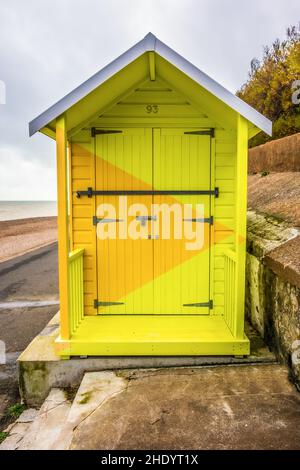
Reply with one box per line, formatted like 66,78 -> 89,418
5,364 -> 300,451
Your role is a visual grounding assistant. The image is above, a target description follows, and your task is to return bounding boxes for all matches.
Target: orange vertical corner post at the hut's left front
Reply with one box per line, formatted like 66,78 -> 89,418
56,115 -> 70,340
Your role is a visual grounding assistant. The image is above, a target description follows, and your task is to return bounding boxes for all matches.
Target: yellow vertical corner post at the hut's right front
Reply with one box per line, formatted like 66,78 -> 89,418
234,115 -> 248,339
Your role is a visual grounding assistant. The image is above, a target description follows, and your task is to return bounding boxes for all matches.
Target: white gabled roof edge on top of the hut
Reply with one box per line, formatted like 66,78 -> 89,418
29,33 -> 272,136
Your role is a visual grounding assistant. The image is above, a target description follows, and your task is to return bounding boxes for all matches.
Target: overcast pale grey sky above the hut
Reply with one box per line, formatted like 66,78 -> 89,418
0,0 -> 300,200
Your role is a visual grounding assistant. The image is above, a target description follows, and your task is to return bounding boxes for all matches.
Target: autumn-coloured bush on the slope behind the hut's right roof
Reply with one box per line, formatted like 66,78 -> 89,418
237,23 -> 300,147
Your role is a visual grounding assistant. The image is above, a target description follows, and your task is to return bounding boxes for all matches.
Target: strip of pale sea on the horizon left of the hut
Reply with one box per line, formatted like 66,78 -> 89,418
0,201 -> 57,221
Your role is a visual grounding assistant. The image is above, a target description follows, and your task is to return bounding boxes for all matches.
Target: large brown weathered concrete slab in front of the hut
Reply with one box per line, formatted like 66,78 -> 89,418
70,365 -> 300,450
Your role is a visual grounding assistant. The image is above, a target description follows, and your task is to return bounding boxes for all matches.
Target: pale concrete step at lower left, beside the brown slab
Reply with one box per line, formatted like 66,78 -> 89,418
14,388 -> 71,450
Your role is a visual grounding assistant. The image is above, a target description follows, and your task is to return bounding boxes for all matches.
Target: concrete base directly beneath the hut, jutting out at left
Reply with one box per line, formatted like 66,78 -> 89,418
18,313 -> 276,406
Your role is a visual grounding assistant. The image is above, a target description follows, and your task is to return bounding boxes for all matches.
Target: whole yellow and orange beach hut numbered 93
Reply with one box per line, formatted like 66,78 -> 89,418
29,33 -> 272,358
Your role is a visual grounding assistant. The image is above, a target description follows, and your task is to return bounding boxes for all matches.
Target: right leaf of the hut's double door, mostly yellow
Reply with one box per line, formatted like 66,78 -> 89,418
153,129 -> 212,315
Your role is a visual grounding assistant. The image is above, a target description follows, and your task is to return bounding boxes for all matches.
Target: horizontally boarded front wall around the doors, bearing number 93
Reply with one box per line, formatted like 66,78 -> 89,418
70,81 -> 236,315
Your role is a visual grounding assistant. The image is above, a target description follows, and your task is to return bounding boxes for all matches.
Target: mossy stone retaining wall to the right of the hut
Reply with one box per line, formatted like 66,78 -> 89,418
246,212 -> 300,391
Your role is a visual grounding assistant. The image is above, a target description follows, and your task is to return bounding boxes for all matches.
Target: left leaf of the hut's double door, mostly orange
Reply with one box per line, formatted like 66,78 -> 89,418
96,128 -> 153,314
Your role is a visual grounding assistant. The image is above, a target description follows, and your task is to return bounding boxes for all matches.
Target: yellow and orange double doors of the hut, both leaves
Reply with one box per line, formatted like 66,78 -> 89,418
94,128 -> 212,315
